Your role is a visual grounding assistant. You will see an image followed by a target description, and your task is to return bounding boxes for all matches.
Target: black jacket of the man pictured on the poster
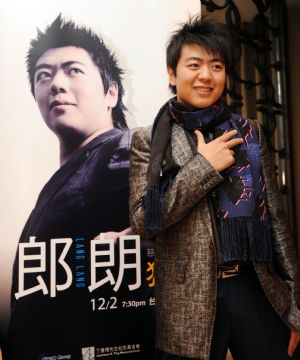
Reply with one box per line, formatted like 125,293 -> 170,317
4,129 -> 154,360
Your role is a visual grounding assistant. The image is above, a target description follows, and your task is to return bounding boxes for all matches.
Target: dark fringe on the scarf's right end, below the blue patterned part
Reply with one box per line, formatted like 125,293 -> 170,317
220,217 -> 272,262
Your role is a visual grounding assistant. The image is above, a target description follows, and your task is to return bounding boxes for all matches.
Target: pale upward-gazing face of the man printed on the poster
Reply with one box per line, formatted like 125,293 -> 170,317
34,46 -> 118,141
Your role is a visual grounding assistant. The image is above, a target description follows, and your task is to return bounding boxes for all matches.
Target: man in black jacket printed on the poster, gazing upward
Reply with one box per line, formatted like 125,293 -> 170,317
4,16 -> 153,360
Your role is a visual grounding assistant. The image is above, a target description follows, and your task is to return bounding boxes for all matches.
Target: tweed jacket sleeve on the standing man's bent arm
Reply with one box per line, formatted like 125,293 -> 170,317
129,128 -> 223,238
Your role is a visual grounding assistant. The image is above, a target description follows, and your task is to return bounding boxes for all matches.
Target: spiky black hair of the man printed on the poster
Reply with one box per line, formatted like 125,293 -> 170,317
26,14 -> 128,130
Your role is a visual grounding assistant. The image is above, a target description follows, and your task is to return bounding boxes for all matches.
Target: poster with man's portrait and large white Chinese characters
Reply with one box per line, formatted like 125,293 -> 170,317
0,0 -> 200,360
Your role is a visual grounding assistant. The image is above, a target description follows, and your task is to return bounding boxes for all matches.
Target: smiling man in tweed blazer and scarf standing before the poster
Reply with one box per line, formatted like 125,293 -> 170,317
130,17 -> 300,360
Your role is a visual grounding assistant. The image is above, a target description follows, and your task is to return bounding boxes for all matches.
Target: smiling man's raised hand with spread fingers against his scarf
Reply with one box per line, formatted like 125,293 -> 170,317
195,130 -> 244,172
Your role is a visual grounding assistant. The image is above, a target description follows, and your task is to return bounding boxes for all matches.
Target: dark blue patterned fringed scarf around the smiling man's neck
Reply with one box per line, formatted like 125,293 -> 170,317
144,99 -> 272,262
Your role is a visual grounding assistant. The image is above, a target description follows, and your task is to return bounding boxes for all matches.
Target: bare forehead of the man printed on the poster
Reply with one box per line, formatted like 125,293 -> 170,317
36,46 -> 94,67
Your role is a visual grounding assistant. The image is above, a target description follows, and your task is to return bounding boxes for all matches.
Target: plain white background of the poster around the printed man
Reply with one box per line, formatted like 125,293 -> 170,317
0,0 -> 201,331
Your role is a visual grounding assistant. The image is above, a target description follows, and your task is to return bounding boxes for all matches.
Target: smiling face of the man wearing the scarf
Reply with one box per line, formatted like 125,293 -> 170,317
168,44 -> 226,108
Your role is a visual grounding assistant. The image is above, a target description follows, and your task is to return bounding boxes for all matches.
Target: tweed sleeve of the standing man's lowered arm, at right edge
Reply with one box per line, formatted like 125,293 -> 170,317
258,120 -> 300,310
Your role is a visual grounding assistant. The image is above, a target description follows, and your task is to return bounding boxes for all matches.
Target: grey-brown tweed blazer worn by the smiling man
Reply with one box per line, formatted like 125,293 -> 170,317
129,119 -> 300,360
